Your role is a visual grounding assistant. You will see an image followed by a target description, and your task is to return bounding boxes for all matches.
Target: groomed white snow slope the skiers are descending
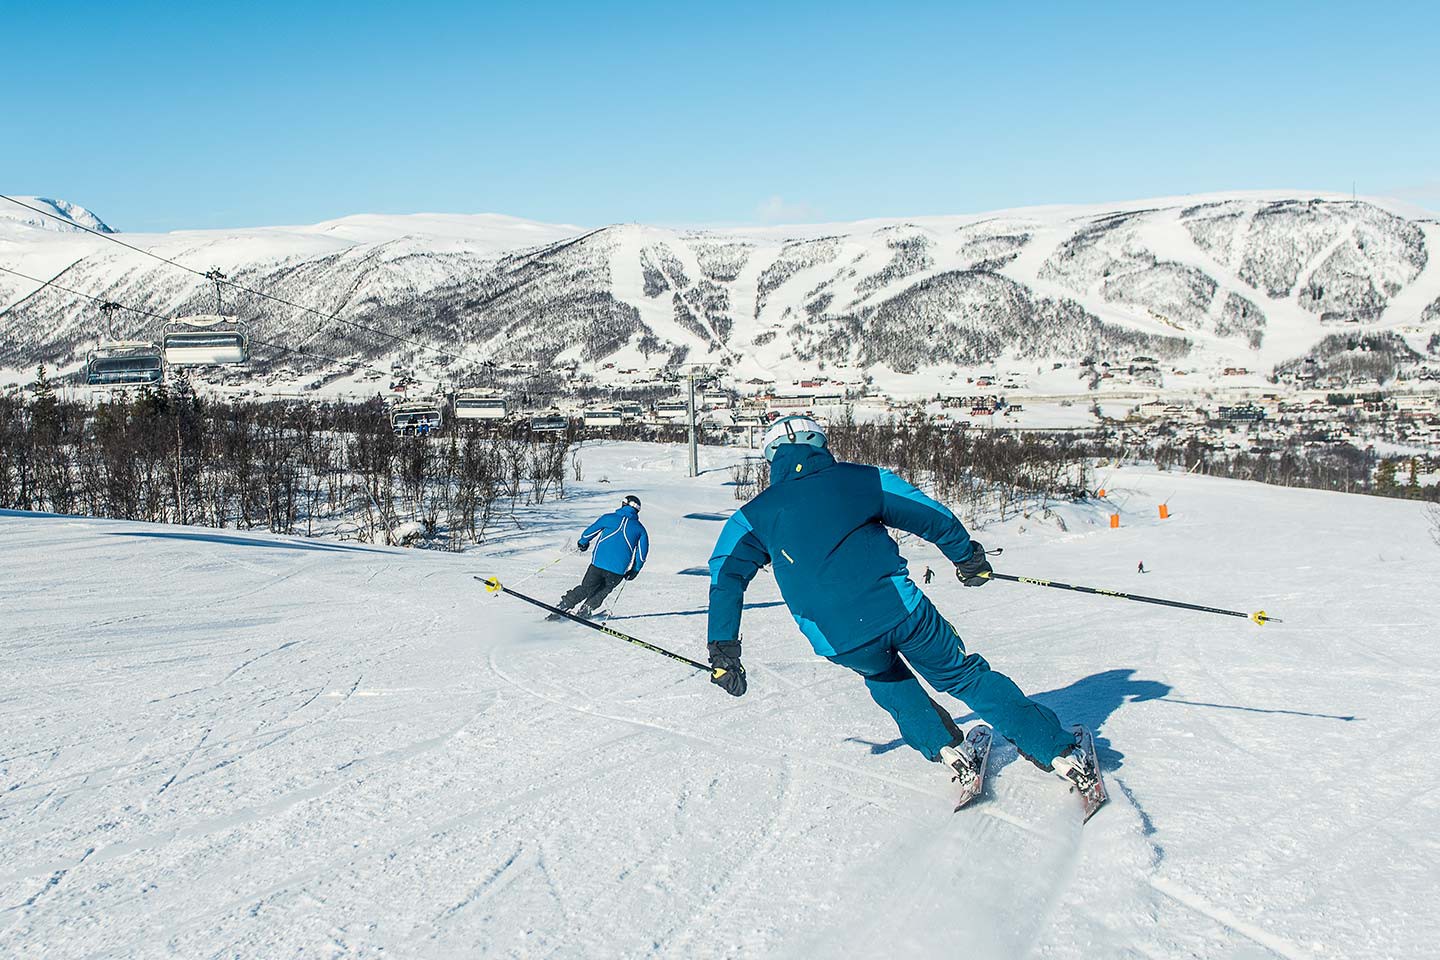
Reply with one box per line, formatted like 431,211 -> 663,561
0,445 -> 1440,959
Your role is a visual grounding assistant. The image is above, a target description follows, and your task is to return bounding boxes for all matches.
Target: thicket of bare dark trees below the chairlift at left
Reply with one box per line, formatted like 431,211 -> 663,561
0,382 -> 577,550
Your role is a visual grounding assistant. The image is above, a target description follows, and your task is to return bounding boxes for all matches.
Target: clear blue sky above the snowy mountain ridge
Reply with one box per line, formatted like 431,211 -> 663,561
0,0 -> 1440,230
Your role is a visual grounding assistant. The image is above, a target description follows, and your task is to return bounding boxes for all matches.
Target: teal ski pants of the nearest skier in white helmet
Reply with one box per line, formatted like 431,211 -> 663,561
828,599 -> 1074,770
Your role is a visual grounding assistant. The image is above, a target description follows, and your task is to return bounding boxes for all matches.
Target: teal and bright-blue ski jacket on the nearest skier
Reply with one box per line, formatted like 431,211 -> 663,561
707,443 -> 971,656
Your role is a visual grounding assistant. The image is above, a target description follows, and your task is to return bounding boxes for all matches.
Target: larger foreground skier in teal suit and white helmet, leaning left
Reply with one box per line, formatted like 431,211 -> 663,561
707,416 -> 1089,780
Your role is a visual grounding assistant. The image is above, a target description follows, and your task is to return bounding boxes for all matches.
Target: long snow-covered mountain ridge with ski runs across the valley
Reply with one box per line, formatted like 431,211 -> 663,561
0,193 -> 1440,389
